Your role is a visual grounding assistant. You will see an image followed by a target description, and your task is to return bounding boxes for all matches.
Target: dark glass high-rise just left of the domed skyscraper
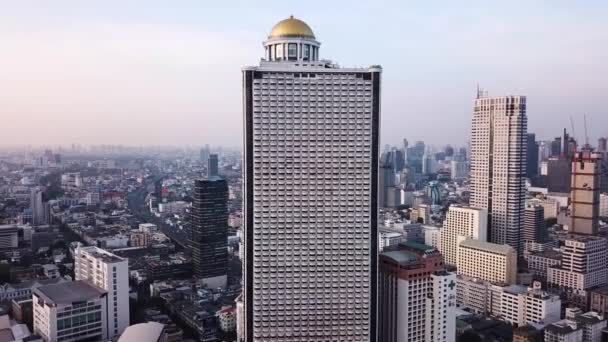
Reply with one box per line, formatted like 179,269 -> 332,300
190,178 -> 228,288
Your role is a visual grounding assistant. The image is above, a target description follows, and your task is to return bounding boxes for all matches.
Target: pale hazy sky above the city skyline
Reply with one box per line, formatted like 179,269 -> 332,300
0,0 -> 608,146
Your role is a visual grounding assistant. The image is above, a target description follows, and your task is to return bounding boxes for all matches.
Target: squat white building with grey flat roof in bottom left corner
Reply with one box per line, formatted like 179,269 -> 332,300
32,281 -> 108,342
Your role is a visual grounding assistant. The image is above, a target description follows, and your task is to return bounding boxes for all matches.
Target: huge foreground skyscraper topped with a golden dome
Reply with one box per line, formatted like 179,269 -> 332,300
243,17 -> 381,342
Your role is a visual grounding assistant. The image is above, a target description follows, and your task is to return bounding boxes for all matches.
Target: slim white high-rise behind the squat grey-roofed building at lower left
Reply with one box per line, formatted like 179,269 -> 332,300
74,247 -> 129,337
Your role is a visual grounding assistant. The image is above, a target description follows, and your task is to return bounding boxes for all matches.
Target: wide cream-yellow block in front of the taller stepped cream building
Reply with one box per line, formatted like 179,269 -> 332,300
456,239 -> 517,284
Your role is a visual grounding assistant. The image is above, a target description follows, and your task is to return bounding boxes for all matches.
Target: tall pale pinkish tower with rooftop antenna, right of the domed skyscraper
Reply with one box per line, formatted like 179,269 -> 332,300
470,93 -> 528,254
